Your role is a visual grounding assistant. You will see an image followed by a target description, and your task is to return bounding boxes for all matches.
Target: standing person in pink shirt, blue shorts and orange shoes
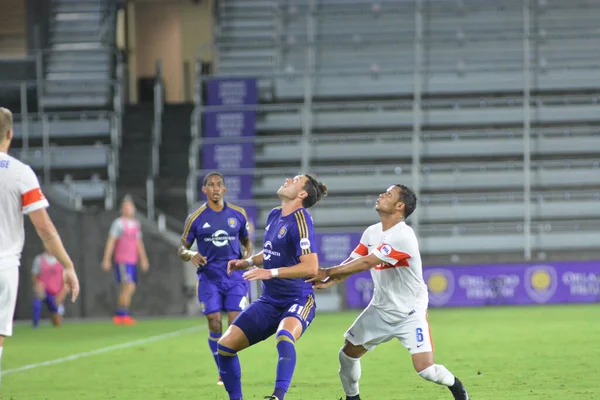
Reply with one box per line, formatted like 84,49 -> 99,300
102,196 -> 150,325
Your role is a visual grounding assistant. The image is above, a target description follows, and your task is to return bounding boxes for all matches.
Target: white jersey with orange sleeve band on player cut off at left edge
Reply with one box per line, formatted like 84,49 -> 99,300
0,152 -> 48,270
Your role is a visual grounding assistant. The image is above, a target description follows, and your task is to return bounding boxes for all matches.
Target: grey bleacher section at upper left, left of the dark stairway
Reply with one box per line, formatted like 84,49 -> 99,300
0,0 -> 121,211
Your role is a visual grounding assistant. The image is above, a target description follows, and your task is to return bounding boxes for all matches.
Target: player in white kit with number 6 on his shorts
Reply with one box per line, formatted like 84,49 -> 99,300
310,185 -> 470,400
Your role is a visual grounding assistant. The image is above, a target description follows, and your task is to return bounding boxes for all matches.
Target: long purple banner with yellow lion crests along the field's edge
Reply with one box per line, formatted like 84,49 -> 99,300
346,261 -> 600,308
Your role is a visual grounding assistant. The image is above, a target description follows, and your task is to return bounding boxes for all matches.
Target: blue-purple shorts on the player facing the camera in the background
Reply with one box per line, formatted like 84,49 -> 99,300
196,279 -> 248,315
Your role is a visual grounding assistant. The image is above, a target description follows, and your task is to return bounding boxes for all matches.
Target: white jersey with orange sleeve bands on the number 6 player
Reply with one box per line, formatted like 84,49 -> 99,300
350,221 -> 429,324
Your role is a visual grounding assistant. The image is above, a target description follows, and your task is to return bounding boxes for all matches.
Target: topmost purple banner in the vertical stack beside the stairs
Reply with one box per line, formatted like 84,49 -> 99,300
206,78 -> 258,106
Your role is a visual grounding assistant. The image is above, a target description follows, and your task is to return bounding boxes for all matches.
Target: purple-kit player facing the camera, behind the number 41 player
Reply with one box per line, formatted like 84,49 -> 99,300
179,172 -> 252,385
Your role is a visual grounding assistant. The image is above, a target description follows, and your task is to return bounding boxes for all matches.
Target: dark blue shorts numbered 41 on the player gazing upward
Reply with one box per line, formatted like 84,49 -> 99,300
233,294 -> 317,345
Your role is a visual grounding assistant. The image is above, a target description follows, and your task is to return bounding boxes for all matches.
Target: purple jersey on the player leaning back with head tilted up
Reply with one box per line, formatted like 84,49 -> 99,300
262,207 -> 317,302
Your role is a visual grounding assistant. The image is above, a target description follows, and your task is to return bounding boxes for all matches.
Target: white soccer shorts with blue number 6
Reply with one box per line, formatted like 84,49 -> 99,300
344,304 -> 433,354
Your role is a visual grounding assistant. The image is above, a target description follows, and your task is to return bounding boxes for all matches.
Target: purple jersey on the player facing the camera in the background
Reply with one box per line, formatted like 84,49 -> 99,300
182,203 -> 248,282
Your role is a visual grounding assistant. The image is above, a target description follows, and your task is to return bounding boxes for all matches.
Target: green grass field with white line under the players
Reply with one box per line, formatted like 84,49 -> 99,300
0,305 -> 600,400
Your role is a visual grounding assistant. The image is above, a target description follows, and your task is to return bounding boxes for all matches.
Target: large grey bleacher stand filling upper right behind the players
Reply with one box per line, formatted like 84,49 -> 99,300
191,0 -> 600,254
